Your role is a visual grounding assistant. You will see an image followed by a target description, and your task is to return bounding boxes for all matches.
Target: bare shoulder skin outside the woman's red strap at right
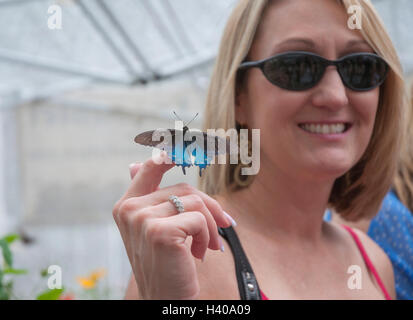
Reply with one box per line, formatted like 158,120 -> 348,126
352,227 -> 396,299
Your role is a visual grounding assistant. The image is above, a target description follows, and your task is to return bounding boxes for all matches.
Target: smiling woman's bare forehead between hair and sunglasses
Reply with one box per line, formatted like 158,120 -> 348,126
252,0 -> 369,56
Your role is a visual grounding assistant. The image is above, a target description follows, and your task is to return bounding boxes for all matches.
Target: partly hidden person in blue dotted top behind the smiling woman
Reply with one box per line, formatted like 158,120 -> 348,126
326,76 -> 413,300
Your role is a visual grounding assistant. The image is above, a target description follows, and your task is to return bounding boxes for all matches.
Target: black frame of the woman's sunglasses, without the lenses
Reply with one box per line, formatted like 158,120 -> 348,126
238,51 -> 389,91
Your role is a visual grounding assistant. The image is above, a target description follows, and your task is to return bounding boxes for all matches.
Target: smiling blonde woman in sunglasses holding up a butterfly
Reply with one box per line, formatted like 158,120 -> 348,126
113,0 -> 405,299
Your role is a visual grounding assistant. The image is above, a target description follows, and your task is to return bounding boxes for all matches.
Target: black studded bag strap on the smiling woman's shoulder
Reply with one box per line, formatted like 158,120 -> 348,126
218,227 -> 261,300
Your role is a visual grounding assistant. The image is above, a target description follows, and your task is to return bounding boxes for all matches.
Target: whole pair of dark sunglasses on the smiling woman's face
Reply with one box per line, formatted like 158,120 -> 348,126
238,51 -> 389,91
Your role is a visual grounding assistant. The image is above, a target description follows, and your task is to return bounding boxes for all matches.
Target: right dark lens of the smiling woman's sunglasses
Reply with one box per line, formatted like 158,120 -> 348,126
339,54 -> 387,91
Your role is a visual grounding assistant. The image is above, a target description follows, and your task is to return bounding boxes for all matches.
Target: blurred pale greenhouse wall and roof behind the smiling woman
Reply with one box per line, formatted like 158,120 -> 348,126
0,0 -> 413,299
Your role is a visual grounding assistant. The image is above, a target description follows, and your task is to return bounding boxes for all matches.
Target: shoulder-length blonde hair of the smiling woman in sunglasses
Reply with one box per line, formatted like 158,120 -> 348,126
199,0 -> 407,220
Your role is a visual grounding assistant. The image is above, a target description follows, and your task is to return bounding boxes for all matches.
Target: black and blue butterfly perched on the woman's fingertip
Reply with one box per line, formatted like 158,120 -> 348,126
134,112 -> 230,176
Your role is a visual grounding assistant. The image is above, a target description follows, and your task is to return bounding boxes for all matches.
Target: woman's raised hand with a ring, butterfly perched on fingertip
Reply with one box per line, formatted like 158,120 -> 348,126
113,153 -> 231,299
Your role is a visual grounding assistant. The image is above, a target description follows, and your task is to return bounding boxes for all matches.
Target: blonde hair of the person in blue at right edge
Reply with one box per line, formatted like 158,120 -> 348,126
393,74 -> 413,212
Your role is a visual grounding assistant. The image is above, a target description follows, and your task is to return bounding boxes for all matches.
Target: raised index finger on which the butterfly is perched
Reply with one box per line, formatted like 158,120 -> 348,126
121,151 -> 175,201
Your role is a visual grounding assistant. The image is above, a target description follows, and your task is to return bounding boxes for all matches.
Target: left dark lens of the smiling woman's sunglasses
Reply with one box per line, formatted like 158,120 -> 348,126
263,54 -> 324,91
